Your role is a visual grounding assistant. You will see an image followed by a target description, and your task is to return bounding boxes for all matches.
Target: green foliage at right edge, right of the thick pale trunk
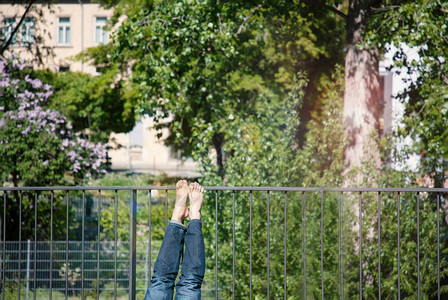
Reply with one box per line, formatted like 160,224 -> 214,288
368,0 -> 448,175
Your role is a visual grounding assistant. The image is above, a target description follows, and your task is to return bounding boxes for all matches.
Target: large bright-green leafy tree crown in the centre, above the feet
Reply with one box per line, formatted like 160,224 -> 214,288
112,1 -> 340,176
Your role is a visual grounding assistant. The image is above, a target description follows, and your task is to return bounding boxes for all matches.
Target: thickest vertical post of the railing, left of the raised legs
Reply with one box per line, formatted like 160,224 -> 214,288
129,189 -> 136,300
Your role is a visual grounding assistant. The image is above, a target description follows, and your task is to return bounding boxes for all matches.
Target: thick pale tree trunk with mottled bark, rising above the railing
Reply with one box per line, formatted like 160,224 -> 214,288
344,0 -> 381,186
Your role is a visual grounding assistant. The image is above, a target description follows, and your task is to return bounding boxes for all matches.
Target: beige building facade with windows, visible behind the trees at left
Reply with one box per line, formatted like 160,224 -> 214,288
0,0 -> 200,177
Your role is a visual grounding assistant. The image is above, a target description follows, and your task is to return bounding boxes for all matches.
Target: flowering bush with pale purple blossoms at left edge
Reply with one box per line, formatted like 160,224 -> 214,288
0,56 -> 106,185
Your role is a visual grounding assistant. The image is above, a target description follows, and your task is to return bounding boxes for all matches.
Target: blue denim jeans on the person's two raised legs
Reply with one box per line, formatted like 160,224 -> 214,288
145,220 -> 205,300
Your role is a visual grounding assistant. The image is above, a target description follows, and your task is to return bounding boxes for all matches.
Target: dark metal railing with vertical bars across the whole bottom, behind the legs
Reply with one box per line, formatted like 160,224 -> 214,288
0,186 -> 448,300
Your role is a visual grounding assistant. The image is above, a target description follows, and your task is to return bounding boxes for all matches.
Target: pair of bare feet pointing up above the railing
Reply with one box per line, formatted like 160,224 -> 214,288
171,180 -> 204,223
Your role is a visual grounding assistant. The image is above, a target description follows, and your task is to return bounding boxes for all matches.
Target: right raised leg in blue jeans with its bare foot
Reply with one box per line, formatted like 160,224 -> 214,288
176,183 -> 205,300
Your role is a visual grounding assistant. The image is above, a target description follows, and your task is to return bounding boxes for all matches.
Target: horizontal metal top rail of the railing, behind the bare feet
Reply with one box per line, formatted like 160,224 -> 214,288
0,186 -> 448,193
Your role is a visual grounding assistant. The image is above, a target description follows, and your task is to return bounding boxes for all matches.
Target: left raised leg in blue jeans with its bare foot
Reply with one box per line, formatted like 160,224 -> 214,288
145,180 -> 189,300
